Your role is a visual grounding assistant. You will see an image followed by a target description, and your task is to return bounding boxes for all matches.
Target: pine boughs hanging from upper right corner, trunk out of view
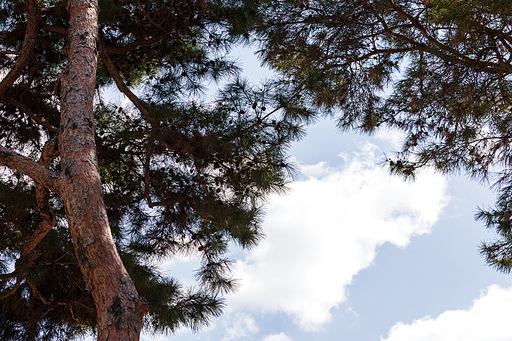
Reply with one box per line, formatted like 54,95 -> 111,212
258,0 -> 512,272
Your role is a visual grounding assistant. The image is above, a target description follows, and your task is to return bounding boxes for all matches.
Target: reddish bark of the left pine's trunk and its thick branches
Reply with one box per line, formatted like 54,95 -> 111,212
0,0 -> 147,334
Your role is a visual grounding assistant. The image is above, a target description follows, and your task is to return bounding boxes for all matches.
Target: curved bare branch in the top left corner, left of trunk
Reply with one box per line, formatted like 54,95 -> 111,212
0,0 -> 39,96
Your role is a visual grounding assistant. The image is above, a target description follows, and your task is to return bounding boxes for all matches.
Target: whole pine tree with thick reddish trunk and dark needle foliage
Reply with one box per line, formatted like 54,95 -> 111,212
0,0 -> 313,340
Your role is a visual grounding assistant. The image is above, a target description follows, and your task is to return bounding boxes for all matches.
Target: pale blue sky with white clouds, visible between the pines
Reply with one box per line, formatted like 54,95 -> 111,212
123,51 -> 512,341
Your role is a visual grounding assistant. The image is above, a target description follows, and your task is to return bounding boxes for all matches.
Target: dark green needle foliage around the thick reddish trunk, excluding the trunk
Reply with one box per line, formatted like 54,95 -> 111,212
0,0 -> 304,340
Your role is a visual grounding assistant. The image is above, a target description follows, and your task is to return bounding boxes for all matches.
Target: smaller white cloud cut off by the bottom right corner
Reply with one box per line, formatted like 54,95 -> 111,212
381,285 -> 512,341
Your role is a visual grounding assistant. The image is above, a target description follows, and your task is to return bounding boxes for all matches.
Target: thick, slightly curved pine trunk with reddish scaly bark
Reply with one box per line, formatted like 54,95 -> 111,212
59,0 -> 146,341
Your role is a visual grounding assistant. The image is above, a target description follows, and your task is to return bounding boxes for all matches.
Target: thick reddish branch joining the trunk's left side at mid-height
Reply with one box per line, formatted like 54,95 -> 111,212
0,146 -> 60,193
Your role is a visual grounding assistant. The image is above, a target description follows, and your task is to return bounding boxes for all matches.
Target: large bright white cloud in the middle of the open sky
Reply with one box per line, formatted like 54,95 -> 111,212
227,143 -> 446,330
